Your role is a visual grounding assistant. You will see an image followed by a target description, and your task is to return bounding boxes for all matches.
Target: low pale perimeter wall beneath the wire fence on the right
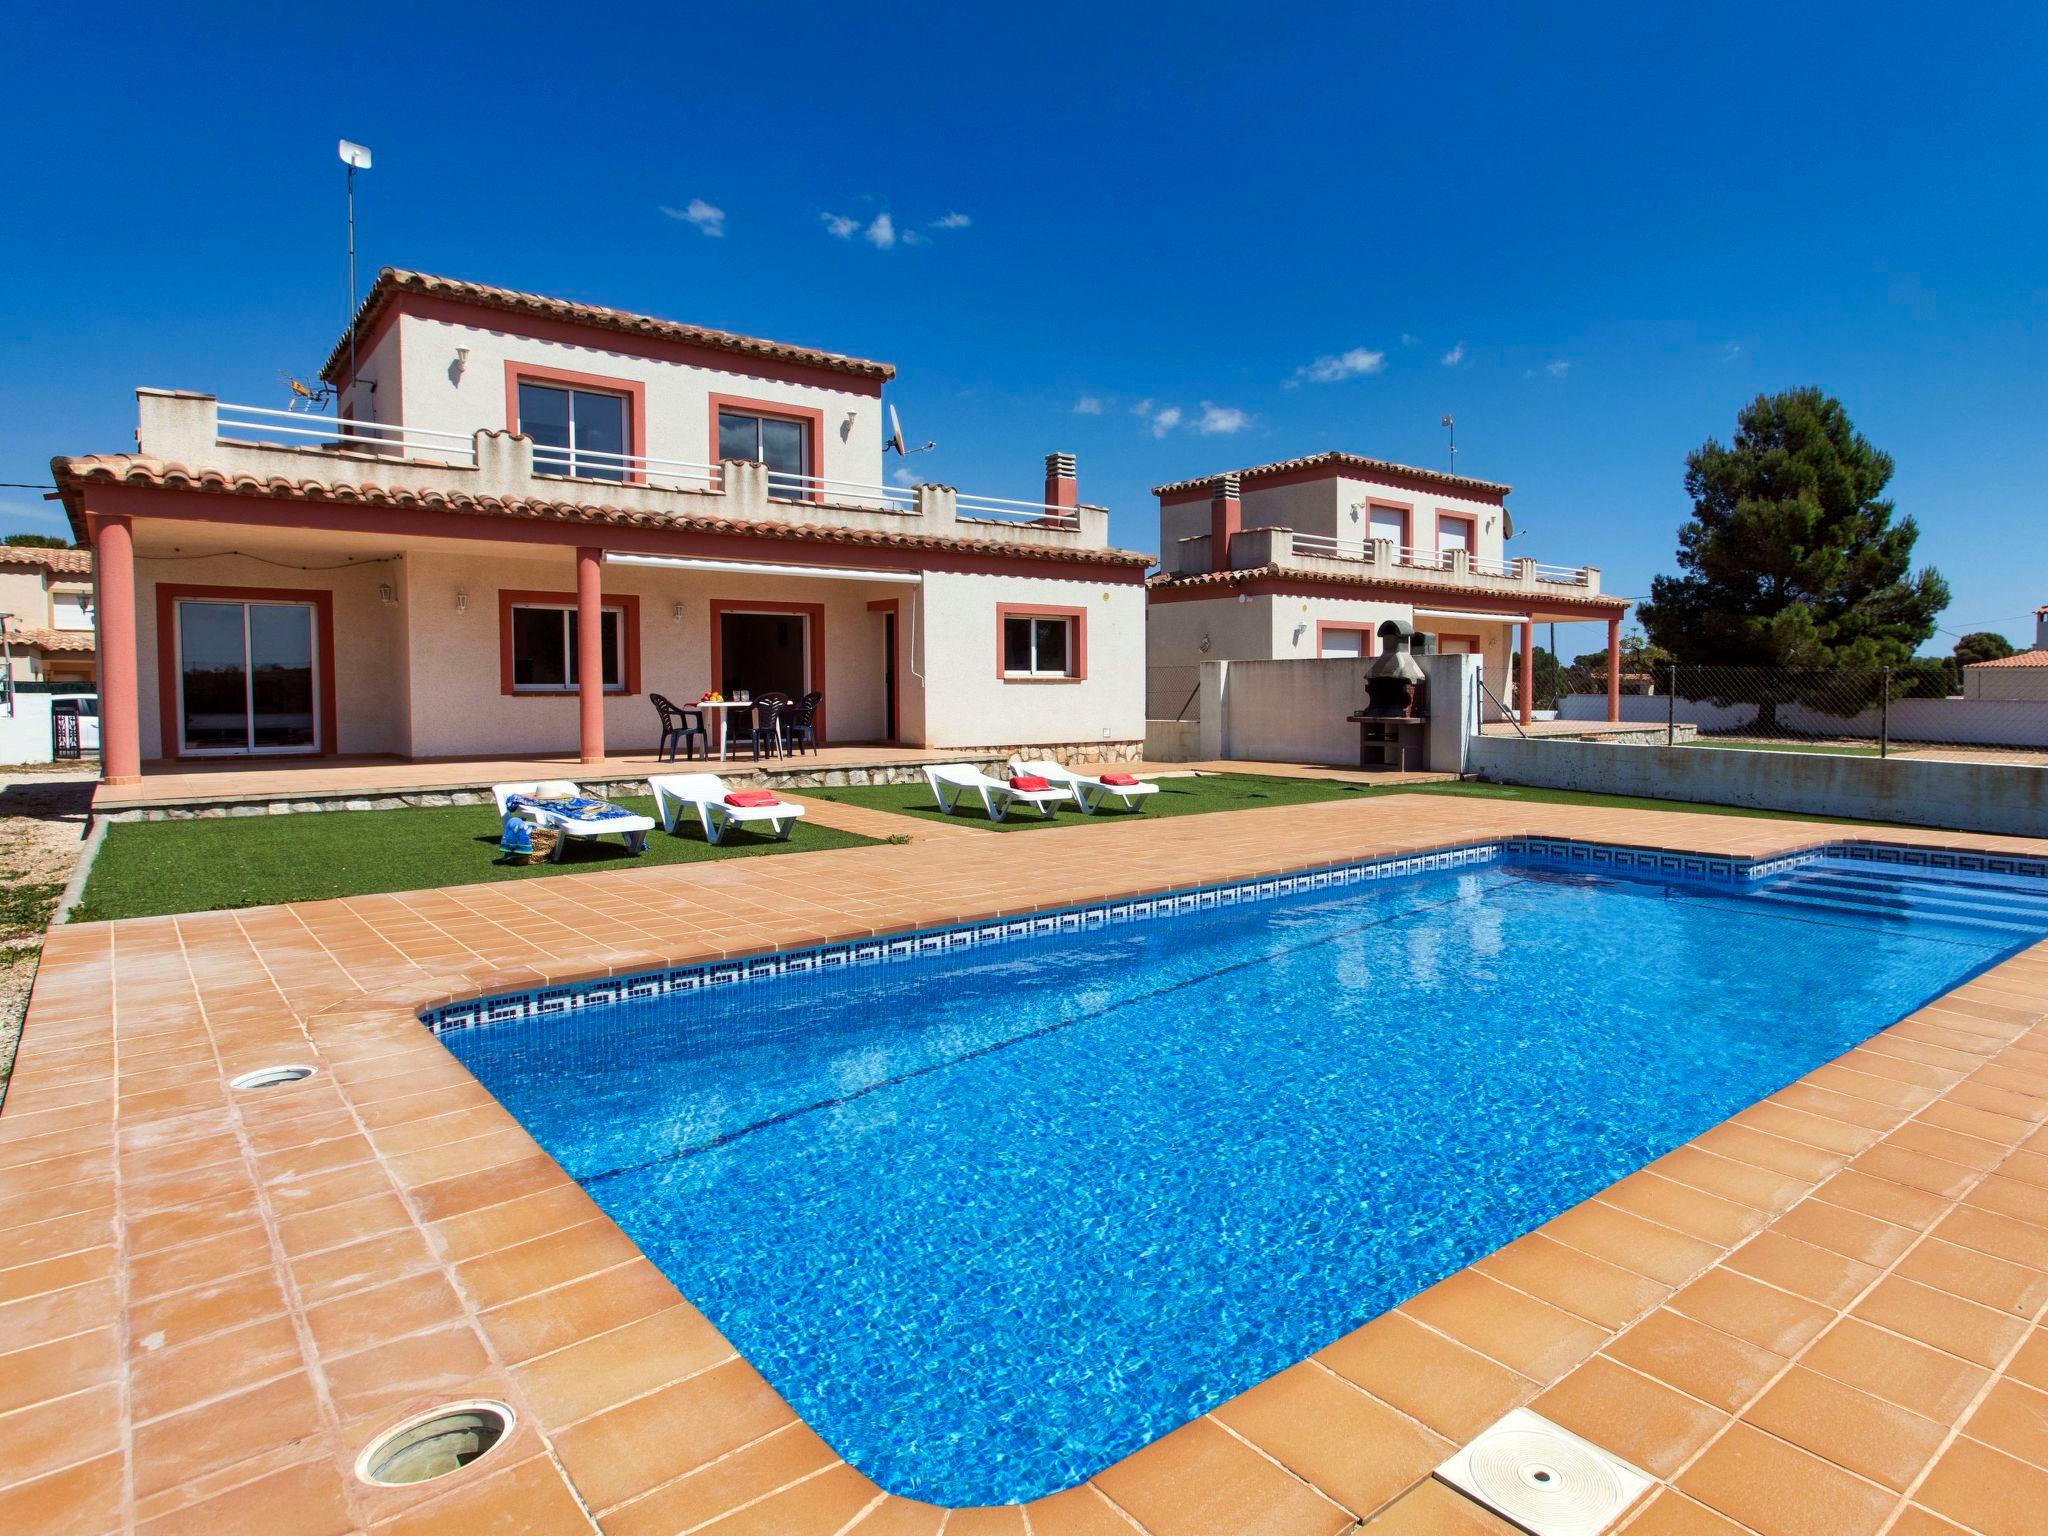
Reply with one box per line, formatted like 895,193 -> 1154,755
1466,737 -> 2048,838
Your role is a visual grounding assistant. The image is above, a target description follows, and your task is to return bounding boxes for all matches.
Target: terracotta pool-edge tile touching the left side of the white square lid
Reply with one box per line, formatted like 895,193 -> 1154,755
1212,1362 -> 1454,1530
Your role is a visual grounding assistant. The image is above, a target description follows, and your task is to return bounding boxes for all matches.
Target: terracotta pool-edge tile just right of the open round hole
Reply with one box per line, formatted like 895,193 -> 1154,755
553,1360 -> 798,1518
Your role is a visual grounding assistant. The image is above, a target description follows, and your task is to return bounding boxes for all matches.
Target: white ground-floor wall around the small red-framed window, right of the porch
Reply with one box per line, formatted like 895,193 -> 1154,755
918,571 -> 1145,748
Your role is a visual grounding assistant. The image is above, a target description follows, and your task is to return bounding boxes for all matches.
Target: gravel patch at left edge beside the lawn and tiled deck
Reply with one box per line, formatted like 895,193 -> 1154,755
0,762 -> 98,1096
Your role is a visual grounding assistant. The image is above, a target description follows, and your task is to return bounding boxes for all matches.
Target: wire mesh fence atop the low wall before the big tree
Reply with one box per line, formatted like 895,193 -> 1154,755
1534,662 -> 2048,762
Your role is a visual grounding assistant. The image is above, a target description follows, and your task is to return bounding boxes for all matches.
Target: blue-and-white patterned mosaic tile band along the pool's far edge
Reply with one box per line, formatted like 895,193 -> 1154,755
420,838 -> 1933,1034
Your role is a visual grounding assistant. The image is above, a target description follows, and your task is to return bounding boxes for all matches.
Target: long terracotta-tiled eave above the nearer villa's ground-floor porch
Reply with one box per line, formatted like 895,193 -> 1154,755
49,453 -> 1153,569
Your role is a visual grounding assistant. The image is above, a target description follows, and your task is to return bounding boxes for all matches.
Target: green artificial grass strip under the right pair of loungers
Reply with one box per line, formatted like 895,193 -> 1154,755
803,774 -> 1916,831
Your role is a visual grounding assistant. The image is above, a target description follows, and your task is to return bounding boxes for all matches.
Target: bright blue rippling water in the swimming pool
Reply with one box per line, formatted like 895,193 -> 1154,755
444,860 -> 2048,1505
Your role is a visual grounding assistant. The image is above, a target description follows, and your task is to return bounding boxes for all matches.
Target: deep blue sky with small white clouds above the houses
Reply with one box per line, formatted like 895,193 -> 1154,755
0,4 -> 2048,653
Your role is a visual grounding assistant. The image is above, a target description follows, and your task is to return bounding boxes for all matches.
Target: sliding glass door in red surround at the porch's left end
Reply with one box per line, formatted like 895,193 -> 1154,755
178,600 -> 319,754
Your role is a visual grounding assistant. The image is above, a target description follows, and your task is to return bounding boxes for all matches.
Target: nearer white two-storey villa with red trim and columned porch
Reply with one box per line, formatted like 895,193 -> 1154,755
53,268 -> 1151,782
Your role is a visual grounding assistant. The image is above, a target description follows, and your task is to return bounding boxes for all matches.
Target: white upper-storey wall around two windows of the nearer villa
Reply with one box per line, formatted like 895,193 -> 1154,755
387,315 -> 883,485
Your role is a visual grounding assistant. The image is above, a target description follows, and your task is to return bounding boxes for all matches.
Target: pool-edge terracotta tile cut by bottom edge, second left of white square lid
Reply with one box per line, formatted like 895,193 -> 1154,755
1094,1419 -> 1354,1536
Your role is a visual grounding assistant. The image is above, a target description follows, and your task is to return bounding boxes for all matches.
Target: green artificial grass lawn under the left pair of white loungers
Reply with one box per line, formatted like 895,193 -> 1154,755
70,797 -> 874,922
